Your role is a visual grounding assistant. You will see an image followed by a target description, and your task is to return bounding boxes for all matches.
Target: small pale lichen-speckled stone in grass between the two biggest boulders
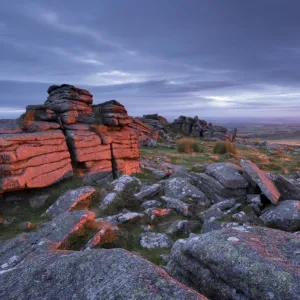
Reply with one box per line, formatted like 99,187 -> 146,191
140,232 -> 173,249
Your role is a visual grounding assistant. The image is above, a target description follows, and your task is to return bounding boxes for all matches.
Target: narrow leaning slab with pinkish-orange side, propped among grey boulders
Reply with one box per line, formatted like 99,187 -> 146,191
241,159 -> 280,204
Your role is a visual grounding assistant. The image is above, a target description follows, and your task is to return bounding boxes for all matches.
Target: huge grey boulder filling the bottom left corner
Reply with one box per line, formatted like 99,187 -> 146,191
0,249 -> 206,300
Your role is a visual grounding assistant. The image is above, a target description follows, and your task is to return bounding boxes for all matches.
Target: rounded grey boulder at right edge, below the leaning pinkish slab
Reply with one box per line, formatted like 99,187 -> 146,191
260,200 -> 300,232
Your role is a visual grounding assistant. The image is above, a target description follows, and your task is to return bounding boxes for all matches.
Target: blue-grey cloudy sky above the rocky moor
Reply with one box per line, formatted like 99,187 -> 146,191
0,0 -> 300,119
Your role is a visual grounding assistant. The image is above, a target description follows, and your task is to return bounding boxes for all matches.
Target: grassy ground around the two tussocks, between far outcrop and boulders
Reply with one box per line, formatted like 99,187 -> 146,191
141,141 -> 300,173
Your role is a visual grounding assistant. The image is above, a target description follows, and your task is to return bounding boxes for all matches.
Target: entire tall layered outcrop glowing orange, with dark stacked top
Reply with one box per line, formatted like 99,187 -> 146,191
0,84 -> 150,193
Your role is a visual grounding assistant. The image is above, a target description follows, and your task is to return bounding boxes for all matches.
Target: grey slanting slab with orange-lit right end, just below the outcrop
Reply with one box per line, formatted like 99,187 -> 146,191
42,186 -> 96,217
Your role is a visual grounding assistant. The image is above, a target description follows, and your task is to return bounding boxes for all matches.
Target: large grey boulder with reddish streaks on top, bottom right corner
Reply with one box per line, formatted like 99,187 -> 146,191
167,226 -> 300,300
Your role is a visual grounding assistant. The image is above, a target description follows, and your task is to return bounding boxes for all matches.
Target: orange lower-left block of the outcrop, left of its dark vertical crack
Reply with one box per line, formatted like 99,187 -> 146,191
0,126 -> 73,194
